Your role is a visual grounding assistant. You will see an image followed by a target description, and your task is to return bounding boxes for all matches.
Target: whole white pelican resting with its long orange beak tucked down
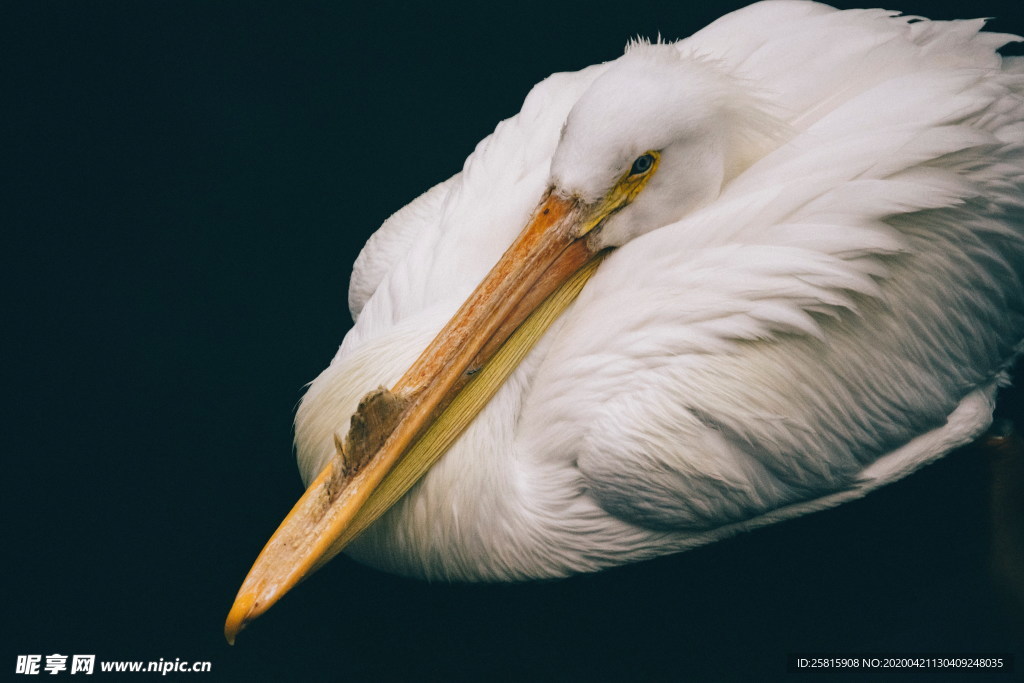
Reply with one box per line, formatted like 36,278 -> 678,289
225,0 -> 1024,642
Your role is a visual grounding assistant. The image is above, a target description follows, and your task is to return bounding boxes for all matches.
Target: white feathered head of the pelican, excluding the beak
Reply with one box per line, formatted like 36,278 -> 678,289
550,43 -> 781,247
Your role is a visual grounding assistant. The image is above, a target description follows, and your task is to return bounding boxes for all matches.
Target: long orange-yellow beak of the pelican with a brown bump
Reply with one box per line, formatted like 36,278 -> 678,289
224,193 -> 607,644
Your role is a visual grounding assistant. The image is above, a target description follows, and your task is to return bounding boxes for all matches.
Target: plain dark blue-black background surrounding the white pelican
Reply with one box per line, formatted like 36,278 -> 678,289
8,0 -> 1024,681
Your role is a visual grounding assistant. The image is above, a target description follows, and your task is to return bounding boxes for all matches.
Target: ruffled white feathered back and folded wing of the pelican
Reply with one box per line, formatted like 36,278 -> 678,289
522,1 -> 1024,529
